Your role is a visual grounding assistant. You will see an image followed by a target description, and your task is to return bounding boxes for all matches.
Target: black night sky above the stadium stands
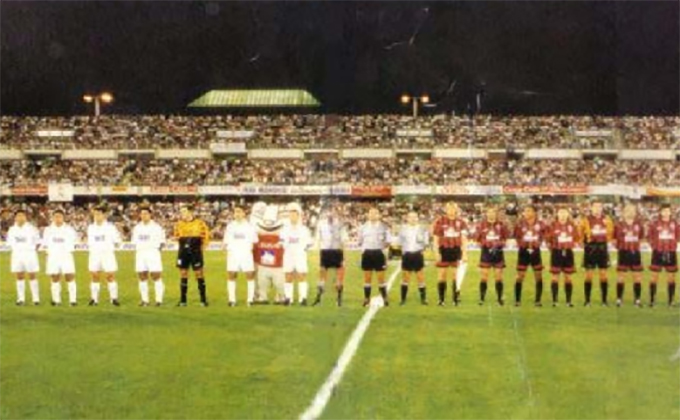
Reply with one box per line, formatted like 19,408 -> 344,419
0,1 -> 680,115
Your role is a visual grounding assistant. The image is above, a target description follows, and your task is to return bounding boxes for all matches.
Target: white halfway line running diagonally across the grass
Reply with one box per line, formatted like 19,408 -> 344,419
300,267 -> 401,420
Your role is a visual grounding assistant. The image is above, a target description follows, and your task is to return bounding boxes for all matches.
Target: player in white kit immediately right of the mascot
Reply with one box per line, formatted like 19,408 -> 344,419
280,204 -> 312,306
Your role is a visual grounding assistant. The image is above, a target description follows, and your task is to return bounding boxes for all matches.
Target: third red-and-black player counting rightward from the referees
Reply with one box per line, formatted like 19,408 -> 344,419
514,205 -> 547,306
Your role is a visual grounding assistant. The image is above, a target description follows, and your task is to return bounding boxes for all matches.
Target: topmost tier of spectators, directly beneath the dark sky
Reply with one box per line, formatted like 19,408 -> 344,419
0,114 -> 680,149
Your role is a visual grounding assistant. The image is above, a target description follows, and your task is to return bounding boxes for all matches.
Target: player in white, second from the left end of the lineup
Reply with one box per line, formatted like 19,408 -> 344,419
42,210 -> 78,306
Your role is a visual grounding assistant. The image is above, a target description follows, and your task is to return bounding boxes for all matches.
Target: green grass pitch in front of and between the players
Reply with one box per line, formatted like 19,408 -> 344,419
0,253 -> 680,419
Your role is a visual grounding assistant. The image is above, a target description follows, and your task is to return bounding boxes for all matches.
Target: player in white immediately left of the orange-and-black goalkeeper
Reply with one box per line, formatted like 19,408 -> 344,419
132,207 -> 166,306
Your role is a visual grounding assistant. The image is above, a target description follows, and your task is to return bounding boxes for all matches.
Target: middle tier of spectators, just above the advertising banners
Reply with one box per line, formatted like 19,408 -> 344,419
0,158 -> 680,187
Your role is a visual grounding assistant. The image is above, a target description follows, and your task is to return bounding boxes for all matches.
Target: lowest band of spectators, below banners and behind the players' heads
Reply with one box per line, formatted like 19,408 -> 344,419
0,197 -> 677,240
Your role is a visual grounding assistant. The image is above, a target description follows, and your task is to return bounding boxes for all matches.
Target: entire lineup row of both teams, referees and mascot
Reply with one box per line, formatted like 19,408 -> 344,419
7,201 -> 680,307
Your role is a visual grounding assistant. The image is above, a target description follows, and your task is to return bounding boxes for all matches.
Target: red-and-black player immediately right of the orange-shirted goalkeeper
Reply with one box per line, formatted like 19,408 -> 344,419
614,204 -> 645,307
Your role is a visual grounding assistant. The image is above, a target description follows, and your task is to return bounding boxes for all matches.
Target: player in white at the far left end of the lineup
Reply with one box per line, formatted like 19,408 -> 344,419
7,210 -> 40,306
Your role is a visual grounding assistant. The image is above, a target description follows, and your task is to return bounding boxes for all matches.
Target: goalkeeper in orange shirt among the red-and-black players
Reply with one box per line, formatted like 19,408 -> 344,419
580,200 -> 614,306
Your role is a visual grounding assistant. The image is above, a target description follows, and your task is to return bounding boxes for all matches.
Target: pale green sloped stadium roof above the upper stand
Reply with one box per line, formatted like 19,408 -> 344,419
189,89 -> 320,108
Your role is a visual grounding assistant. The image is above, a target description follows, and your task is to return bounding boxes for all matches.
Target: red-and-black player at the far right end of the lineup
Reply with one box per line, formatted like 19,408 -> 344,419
648,204 -> 680,307
